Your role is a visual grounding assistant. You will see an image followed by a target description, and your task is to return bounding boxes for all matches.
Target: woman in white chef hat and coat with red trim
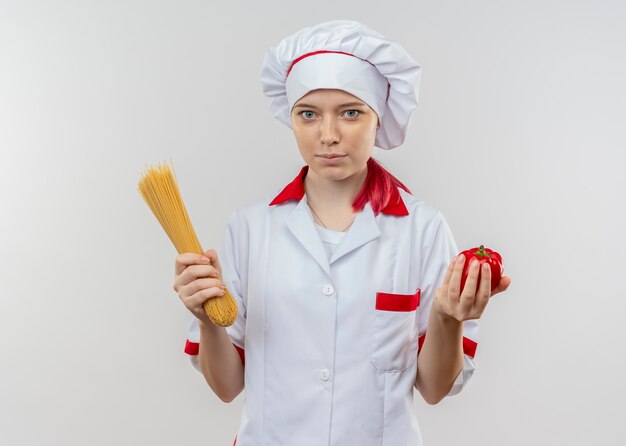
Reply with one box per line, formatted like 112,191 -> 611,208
169,20 -> 510,446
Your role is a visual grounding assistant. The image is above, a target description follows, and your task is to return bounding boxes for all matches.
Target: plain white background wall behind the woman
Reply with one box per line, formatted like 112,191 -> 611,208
0,0 -> 626,446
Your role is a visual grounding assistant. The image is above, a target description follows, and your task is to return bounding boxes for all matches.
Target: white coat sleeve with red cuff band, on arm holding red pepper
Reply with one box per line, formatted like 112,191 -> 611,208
418,212 -> 478,396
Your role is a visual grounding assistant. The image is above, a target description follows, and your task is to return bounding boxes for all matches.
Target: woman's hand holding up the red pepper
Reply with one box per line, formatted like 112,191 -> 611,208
433,255 -> 511,321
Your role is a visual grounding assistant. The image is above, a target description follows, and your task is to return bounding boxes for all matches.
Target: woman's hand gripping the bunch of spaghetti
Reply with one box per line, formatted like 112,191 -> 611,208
174,249 -> 226,322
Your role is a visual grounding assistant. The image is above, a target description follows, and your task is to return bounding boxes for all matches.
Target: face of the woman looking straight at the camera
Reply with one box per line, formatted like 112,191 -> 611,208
291,89 -> 378,180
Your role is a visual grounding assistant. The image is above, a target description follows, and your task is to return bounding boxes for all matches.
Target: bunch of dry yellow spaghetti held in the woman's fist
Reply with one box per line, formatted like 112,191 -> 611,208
137,163 -> 237,327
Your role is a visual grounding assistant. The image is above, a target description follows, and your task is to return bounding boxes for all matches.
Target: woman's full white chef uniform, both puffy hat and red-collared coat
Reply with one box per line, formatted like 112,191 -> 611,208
185,20 -> 478,446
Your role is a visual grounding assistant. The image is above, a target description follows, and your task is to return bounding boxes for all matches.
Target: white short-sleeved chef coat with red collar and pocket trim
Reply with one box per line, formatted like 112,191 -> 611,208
185,167 -> 478,446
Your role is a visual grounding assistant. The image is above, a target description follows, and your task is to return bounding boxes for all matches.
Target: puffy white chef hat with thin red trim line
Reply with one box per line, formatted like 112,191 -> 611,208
261,20 -> 421,149
